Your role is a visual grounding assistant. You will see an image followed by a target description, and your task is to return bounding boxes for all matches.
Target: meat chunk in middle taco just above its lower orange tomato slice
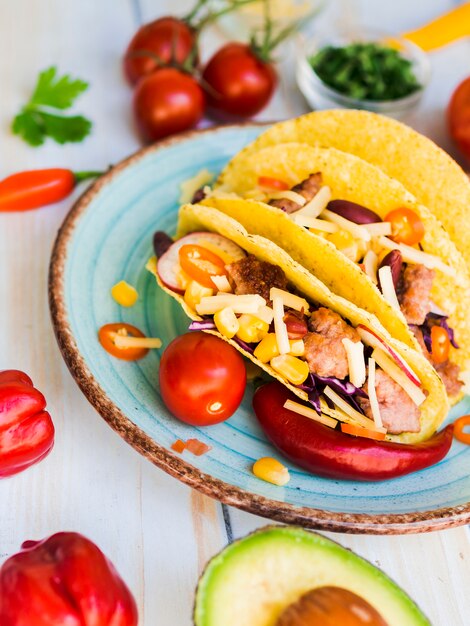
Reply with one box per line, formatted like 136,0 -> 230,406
397,265 -> 434,326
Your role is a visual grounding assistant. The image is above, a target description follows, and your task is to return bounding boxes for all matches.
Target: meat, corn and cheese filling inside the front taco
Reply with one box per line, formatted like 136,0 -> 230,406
151,227 -> 426,437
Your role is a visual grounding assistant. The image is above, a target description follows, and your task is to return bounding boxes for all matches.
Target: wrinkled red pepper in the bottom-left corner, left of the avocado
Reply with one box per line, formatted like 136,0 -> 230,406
0,533 -> 137,626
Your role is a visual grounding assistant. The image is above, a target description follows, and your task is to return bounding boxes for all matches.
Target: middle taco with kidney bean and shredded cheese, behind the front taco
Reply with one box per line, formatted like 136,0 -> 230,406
210,143 -> 470,402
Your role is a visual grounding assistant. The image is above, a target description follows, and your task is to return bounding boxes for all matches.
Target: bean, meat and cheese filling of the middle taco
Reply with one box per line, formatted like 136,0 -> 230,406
205,171 -> 463,398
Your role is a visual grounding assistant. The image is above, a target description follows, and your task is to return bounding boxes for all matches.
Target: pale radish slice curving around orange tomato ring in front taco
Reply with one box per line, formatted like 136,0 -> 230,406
157,232 -> 245,293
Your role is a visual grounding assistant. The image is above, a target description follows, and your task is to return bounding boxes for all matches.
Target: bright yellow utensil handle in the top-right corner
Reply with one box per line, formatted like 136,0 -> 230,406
402,2 -> 470,52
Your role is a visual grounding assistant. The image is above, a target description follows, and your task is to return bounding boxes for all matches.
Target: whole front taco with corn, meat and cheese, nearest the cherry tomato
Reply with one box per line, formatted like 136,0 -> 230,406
147,205 -> 448,443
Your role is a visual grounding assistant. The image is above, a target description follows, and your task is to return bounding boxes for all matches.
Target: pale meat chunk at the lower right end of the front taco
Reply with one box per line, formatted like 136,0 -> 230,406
356,369 -> 421,435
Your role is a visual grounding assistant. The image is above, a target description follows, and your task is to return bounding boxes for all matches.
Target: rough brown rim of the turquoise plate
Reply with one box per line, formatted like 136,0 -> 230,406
48,122 -> 470,535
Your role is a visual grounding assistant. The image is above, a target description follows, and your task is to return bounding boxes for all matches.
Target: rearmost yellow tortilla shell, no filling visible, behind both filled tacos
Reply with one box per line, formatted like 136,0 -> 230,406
219,109 -> 470,268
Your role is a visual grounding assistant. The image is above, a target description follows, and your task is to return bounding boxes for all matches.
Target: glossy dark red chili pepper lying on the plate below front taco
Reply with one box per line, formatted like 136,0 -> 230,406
253,382 -> 453,481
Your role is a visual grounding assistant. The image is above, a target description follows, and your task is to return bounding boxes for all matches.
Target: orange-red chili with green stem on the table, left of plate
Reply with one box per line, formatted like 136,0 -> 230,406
0,168 -> 102,212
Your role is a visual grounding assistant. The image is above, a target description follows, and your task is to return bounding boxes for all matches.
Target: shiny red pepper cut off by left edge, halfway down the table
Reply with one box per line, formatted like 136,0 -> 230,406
0,370 -> 54,476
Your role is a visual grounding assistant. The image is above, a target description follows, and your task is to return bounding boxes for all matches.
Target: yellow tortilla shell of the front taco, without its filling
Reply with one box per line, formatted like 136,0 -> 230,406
147,205 -> 449,443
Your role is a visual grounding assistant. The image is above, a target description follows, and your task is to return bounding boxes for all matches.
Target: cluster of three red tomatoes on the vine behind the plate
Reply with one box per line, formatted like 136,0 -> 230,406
124,16 -> 277,142
